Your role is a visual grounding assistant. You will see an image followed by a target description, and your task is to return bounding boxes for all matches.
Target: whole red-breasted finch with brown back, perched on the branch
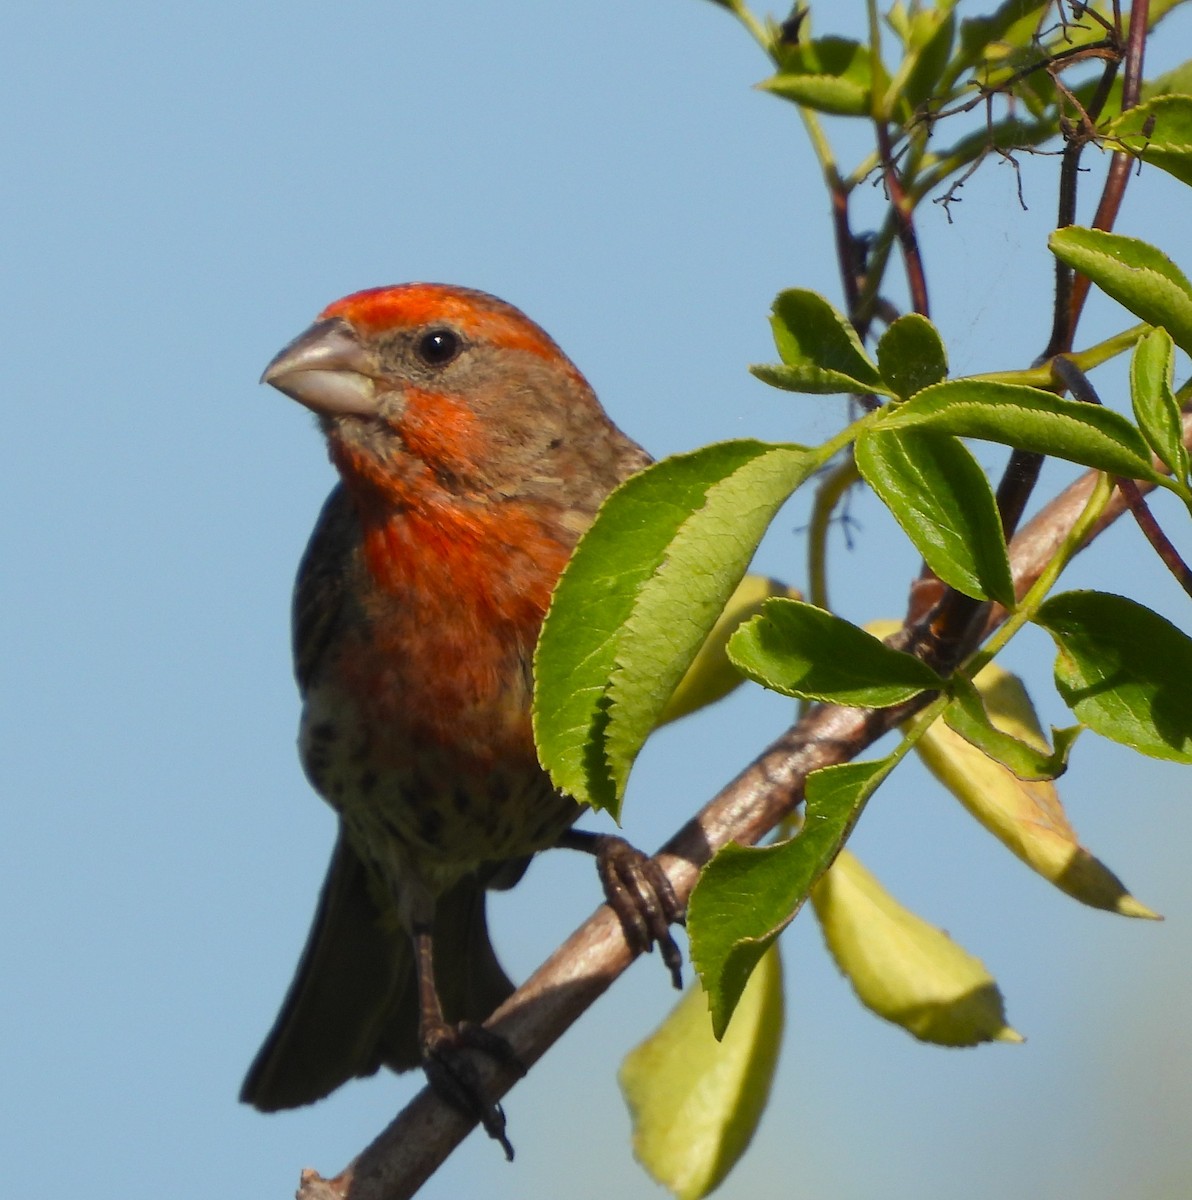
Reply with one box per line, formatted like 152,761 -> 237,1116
241,283 -> 681,1157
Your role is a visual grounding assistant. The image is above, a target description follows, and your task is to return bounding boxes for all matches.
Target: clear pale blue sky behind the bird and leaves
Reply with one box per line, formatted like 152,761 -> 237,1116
0,0 -> 1192,1200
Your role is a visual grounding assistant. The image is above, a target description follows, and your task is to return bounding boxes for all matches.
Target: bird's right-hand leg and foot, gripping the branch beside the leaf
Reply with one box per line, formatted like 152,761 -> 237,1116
557,829 -> 684,988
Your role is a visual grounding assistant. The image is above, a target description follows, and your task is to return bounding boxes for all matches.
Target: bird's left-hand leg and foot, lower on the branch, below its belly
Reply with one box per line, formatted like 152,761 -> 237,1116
411,924 -> 526,1162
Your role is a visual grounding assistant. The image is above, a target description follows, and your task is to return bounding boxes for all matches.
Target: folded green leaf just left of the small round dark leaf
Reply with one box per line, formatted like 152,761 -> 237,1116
753,288 -> 883,392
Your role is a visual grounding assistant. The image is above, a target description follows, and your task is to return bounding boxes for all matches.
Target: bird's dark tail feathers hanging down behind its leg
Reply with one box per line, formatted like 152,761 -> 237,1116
240,833 -> 513,1112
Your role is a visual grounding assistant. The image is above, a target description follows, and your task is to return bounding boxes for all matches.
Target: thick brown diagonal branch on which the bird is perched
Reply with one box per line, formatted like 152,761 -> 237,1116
290,415 -> 1192,1200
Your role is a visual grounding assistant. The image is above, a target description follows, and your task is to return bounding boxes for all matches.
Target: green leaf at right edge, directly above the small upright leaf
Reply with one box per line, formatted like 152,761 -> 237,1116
1048,225 -> 1192,353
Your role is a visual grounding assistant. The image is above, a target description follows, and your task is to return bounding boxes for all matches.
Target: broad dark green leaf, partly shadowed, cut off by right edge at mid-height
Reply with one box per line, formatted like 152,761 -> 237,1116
1035,592 -> 1192,762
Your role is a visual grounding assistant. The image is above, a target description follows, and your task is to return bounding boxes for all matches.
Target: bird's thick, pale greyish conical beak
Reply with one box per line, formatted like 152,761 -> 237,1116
260,317 -> 377,416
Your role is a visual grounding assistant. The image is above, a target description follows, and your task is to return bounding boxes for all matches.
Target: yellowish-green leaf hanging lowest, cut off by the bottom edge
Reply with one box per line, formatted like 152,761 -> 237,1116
618,946 -> 784,1200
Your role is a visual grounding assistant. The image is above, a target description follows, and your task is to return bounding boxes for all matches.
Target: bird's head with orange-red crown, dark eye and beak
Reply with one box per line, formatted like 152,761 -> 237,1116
262,283 -> 643,504
